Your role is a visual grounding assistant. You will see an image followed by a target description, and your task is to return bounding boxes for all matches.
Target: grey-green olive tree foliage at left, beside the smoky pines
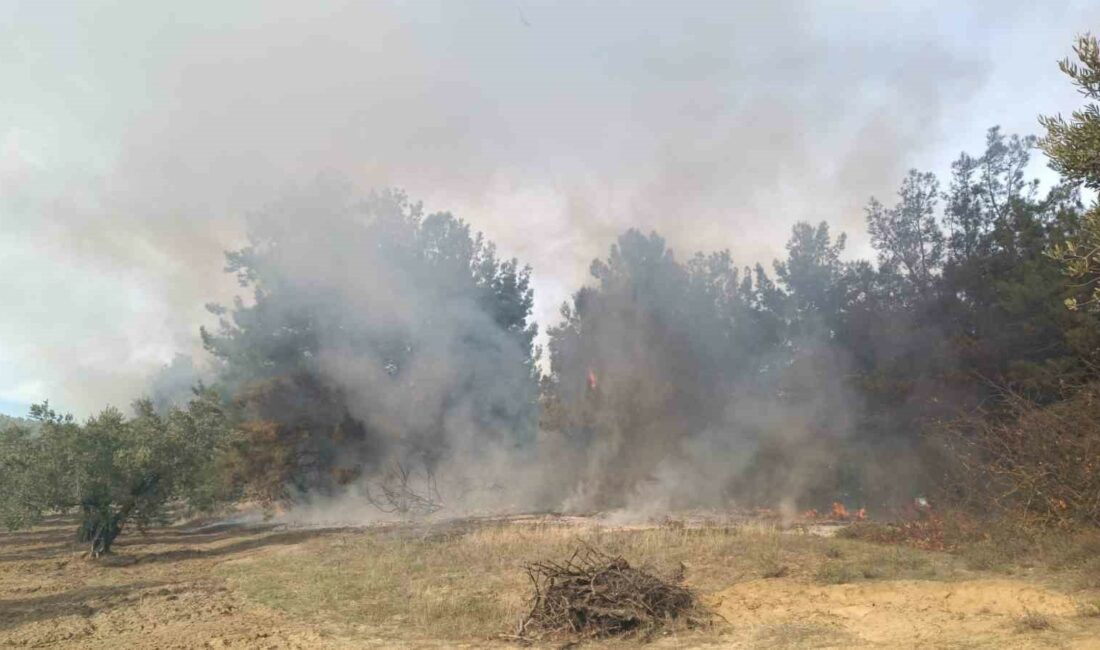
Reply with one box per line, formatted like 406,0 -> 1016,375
0,390 -> 228,557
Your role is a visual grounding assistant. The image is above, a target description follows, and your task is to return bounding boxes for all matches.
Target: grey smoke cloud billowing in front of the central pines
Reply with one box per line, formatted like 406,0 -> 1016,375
240,202 -> 866,524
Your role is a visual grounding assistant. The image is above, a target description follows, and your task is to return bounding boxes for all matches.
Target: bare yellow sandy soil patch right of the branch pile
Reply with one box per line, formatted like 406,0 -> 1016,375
710,580 -> 1100,649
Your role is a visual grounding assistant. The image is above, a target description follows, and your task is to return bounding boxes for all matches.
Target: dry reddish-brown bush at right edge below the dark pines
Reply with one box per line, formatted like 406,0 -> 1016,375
938,384 -> 1100,527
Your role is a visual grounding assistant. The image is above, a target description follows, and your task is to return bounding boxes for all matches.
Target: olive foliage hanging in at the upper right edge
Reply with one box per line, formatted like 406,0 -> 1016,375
1040,34 -> 1100,309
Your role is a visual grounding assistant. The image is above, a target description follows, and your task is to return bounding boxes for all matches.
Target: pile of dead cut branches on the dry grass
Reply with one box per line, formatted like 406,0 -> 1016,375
517,547 -> 697,639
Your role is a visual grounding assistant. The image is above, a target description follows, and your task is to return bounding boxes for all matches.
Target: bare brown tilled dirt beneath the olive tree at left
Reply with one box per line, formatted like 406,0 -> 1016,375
0,520 -> 345,648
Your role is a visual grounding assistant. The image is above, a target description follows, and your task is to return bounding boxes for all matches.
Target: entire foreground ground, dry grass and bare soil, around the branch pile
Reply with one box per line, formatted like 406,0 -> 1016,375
0,517 -> 1100,648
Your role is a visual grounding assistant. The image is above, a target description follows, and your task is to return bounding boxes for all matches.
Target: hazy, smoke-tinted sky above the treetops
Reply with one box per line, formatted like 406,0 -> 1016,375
0,0 -> 1100,416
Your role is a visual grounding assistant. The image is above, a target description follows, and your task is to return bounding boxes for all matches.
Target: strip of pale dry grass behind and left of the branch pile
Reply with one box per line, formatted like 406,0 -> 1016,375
223,524 -> 956,640
